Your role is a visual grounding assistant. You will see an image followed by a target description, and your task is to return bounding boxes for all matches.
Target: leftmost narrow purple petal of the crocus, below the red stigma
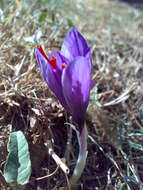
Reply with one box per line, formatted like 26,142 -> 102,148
35,48 -> 68,109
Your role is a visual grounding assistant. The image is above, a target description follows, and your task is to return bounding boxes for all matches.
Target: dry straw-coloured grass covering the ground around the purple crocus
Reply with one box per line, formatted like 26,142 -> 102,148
0,0 -> 143,190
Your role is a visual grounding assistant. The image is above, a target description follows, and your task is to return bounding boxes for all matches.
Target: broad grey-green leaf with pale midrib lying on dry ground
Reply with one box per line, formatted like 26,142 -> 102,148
4,131 -> 31,185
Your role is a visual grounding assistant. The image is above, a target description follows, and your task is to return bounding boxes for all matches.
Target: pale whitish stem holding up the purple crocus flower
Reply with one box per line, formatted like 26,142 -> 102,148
70,123 -> 88,190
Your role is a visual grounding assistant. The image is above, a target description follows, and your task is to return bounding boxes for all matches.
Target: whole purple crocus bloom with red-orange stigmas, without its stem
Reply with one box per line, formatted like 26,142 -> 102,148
35,28 -> 91,127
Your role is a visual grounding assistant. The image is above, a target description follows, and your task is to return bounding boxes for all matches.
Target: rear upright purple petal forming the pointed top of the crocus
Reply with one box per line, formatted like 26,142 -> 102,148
61,28 -> 90,61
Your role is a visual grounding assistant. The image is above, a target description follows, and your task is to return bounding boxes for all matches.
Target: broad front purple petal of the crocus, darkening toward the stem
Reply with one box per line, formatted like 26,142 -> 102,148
62,57 -> 91,124
